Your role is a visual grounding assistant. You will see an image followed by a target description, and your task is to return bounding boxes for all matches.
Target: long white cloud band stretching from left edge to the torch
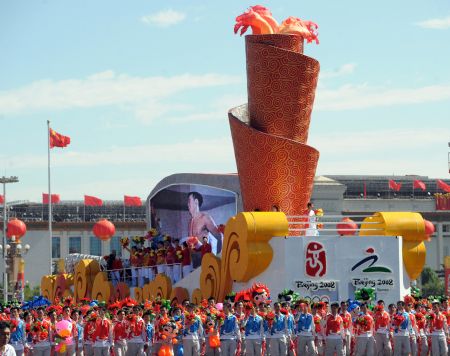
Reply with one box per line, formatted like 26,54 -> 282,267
0,70 -> 241,122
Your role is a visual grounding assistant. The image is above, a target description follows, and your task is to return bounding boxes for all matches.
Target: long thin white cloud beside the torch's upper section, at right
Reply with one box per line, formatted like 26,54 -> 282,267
314,84 -> 450,111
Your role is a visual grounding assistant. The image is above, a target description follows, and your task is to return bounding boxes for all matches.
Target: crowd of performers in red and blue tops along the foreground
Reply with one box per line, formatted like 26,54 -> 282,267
0,284 -> 450,356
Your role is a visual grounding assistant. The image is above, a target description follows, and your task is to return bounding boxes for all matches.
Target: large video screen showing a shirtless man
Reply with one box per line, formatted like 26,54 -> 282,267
150,184 -> 236,254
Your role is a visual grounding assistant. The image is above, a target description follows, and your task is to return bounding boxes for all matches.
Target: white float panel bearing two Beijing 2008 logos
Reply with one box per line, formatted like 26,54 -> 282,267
233,236 -> 409,302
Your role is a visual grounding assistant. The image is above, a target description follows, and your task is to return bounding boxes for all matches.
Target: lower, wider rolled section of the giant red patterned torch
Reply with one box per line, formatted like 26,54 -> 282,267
229,107 -> 319,215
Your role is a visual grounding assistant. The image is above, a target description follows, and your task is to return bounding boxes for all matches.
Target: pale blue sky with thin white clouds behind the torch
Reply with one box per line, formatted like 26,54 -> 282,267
0,0 -> 450,201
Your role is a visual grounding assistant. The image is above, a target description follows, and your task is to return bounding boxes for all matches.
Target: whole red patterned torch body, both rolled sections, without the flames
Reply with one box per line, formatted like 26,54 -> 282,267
229,34 -> 320,215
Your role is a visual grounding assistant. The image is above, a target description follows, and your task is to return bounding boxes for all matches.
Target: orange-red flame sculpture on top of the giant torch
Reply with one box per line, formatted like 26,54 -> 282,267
234,5 -> 319,44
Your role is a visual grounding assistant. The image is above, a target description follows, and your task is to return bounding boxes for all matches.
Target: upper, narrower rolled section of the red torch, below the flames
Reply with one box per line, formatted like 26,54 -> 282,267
245,34 -> 320,143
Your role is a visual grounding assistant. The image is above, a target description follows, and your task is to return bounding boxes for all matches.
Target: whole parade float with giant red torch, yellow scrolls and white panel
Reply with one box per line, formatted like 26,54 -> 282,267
41,6 -> 429,303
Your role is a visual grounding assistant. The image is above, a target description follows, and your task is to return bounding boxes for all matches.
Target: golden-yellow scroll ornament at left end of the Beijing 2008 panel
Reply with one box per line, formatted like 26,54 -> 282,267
200,212 -> 288,301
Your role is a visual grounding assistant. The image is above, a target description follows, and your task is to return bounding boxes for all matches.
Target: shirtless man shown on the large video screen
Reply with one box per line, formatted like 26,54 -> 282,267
188,192 -> 222,253
